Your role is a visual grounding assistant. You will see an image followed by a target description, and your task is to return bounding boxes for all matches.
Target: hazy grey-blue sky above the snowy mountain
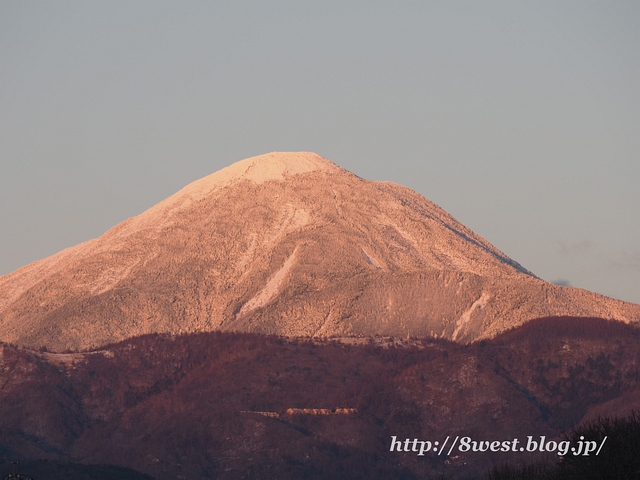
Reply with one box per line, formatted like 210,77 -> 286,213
0,0 -> 640,303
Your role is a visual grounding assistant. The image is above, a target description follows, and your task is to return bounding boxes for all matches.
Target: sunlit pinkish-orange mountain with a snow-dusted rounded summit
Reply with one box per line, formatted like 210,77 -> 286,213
0,153 -> 640,351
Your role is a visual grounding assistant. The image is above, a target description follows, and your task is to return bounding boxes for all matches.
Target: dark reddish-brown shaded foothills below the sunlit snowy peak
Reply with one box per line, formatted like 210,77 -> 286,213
0,317 -> 640,480
